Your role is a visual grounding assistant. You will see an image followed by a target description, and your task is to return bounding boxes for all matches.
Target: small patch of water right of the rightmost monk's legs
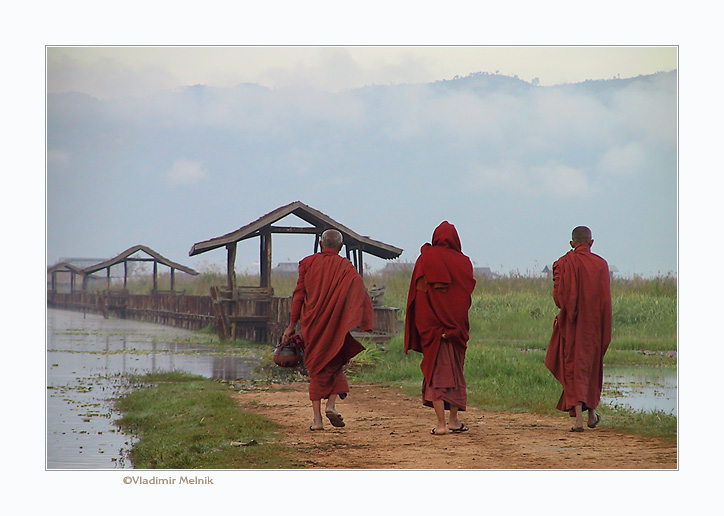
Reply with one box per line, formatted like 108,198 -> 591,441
601,366 -> 678,416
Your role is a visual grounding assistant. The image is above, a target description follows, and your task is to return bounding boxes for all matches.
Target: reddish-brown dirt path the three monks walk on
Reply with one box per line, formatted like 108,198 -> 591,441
234,383 -> 677,469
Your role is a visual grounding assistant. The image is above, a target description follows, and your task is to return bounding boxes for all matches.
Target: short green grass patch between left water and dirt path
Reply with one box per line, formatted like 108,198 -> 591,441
116,372 -> 296,469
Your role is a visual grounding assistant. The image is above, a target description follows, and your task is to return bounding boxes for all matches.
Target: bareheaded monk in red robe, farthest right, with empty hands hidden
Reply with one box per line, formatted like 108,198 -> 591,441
545,226 -> 611,432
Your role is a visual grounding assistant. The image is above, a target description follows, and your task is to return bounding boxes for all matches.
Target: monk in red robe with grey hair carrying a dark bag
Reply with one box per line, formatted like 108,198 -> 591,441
282,229 -> 373,430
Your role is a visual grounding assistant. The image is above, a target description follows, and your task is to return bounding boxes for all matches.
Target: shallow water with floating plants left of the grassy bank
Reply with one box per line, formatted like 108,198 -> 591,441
46,309 -> 258,469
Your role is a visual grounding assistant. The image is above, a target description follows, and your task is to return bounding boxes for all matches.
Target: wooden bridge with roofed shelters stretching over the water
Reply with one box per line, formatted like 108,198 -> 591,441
47,201 -> 402,344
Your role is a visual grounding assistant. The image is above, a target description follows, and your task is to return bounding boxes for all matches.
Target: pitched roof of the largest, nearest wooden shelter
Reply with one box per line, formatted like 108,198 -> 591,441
189,201 -> 402,260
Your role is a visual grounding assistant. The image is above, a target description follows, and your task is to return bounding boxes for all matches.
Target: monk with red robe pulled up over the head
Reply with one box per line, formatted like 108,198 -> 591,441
405,221 -> 475,435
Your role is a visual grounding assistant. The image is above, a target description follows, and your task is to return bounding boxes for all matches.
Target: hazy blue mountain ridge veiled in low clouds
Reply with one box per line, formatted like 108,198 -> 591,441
47,71 -> 677,273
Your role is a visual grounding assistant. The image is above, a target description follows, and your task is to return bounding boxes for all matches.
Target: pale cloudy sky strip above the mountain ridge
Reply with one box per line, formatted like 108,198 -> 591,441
48,46 -> 677,99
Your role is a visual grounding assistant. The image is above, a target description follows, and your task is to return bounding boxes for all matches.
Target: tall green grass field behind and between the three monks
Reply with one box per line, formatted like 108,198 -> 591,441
116,271 -> 677,439
